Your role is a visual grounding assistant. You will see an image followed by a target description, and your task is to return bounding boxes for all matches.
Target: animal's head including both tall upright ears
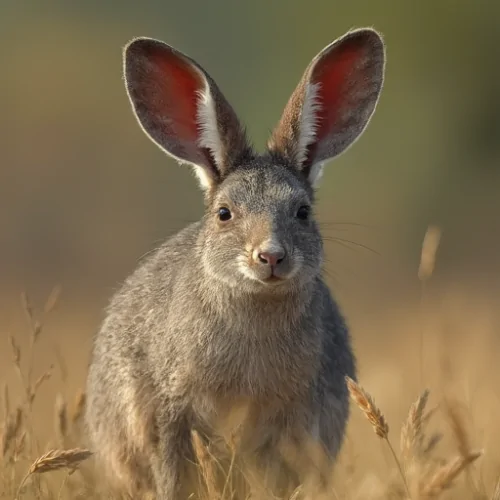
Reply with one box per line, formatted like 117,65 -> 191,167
124,29 -> 385,292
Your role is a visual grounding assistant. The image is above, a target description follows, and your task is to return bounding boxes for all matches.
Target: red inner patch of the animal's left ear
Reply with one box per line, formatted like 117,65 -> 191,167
149,49 -> 204,146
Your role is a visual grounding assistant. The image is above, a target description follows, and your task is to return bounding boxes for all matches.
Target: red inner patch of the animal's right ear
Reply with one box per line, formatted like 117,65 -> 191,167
307,40 -> 366,163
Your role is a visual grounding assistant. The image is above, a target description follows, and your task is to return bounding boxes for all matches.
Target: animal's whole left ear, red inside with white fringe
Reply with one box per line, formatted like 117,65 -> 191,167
123,38 -> 249,189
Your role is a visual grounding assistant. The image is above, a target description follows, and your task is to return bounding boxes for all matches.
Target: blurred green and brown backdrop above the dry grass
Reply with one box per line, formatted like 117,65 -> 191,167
0,0 -> 500,460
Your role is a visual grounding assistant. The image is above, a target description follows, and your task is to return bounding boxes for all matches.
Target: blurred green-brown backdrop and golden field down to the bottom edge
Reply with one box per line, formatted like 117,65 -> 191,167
0,0 -> 500,500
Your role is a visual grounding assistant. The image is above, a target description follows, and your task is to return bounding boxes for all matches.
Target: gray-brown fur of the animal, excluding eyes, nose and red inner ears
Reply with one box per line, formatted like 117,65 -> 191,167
86,30 -> 383,500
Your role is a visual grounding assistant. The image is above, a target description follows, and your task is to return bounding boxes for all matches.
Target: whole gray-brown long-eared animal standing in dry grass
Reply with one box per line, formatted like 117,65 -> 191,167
86,28 -> 385,500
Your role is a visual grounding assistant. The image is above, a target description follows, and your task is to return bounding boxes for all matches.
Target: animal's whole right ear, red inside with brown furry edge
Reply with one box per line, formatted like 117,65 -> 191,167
268,28 -> 385,185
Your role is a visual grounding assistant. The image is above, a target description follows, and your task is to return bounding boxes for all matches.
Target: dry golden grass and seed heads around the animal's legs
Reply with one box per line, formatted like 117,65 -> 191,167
0,228 -> 500,500
